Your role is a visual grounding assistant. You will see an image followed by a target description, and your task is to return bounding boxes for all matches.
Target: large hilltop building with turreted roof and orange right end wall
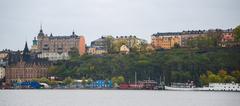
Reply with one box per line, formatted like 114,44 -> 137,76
32,28 -> 85,60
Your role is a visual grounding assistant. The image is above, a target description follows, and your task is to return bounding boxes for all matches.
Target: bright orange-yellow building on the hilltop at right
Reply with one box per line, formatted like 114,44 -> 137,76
151,32 -> 181,49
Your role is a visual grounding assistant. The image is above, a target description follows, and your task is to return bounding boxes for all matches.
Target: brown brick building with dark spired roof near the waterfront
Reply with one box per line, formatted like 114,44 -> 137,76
5,43 -> 51,84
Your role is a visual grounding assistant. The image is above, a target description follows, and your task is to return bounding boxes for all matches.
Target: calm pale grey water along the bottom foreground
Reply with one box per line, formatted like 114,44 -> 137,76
0,90 -> 240,106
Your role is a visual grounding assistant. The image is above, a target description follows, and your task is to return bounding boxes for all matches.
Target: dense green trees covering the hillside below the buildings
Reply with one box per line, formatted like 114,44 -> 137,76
49,48 -> 240,85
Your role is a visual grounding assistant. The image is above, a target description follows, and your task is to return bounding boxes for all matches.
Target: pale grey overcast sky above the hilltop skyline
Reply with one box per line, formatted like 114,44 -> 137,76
0,0 -> 240,50
